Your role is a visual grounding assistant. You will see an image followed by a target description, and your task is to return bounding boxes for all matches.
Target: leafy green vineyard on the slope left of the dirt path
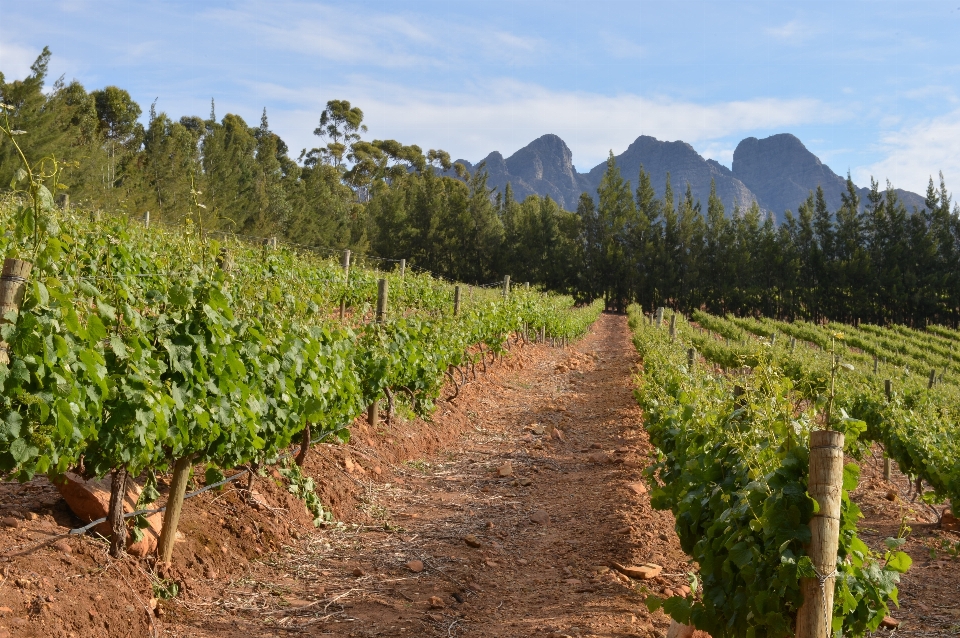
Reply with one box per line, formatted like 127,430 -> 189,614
0,188 -> 601,561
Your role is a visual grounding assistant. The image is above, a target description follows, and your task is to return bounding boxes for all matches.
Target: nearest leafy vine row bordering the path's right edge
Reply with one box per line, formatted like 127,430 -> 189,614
630,306 -> 909,638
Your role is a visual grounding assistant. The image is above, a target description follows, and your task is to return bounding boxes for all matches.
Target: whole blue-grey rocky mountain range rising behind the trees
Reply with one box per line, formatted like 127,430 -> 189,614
457,133 -> 923,220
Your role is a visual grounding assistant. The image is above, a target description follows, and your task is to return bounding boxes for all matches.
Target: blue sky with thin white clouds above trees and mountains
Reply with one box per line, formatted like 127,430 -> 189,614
0,0 -> 960,193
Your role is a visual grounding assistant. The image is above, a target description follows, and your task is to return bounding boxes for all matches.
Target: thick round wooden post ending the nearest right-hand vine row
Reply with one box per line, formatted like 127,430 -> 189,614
796,430 -> 843,638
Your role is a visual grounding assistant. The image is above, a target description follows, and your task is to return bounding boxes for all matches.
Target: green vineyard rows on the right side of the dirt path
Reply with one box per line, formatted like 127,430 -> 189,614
631,307 -> 960,638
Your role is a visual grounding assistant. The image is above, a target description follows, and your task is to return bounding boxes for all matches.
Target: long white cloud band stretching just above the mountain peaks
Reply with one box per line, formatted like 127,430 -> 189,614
254,80 -> 847,171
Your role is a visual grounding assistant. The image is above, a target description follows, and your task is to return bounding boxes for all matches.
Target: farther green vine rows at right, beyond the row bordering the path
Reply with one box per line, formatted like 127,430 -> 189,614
690,312 -> 960,508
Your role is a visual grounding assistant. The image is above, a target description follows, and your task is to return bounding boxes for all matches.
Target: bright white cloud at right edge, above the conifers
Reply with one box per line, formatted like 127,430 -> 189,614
853,109 -> 960,193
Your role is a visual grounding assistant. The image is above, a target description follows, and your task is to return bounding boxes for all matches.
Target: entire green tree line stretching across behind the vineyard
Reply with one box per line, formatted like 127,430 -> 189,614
0,49 -> 960,325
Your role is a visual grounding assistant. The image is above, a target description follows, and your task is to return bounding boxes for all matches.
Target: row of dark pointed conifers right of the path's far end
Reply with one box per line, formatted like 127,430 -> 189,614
578,155 -> 960,325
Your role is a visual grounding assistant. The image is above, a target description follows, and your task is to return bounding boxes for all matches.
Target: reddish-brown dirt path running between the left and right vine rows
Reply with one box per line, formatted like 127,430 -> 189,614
164,315 -> 688,637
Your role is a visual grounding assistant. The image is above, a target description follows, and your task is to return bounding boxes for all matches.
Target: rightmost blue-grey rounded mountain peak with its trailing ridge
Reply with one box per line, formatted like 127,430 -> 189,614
733,133 -> 923,216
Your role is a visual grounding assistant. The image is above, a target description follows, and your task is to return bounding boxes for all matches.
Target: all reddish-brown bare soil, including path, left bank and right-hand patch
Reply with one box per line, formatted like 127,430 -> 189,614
0,315 -> 960,638
